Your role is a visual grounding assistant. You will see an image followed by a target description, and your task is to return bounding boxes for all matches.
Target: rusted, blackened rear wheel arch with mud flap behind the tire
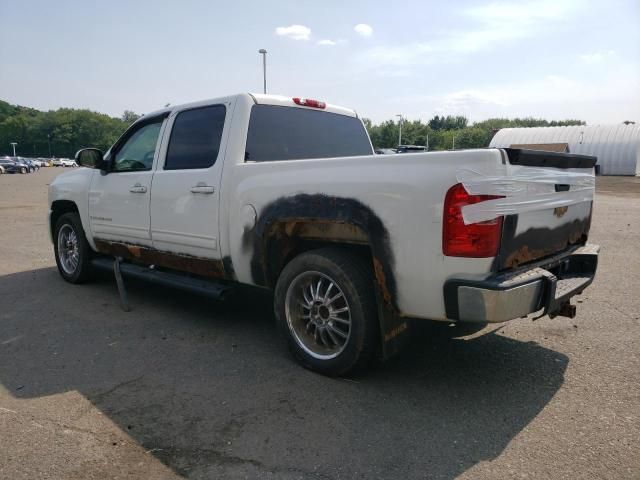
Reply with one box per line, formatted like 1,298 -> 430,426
248,194 -> 407,358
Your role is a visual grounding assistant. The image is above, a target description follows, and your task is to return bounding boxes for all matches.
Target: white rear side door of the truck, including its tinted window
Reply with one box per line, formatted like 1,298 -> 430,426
151,103 -> 231,259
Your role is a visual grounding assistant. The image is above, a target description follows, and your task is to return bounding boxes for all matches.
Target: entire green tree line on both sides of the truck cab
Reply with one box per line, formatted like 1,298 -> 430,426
0,100 -> 585,157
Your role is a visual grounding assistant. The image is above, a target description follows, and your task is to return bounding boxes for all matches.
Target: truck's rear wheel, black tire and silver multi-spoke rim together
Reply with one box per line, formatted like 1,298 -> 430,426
274,247 -> 379,376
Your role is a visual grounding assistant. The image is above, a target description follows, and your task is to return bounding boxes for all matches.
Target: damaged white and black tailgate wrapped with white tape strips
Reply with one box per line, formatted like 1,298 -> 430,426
459,148 -> 596,270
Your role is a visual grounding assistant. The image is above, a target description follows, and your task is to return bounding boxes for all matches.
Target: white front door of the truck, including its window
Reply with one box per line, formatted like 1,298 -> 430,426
89,117 -> 164,246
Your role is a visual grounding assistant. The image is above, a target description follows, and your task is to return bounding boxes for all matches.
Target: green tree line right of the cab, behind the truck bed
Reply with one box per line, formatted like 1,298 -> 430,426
363,115 -> 586,150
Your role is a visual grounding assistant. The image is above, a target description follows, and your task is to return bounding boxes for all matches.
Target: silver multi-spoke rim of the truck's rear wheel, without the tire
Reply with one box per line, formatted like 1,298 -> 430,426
285,272 -> 351,360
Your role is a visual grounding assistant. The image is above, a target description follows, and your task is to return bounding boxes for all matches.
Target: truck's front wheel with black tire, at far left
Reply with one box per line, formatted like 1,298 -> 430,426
53,212 -> 93,283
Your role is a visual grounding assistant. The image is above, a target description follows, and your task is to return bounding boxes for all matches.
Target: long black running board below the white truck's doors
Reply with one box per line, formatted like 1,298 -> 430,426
91,257 -> 233,299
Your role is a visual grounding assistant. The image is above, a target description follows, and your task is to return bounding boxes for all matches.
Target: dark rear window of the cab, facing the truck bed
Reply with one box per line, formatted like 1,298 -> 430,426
245,105 -> 373,162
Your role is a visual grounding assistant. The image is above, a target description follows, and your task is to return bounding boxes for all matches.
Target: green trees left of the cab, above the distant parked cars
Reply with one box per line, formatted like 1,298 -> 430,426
0,100 -> 139,158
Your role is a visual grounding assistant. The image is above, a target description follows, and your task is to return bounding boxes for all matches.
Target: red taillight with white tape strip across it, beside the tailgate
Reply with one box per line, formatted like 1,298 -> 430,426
442,183 -> 502,258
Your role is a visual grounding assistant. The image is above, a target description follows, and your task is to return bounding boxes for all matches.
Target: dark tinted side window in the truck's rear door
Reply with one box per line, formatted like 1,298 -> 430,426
164,105 -> 227,170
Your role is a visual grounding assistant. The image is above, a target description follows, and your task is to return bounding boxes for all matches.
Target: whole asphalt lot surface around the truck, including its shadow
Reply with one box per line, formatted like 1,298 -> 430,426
0,168 -> 640,480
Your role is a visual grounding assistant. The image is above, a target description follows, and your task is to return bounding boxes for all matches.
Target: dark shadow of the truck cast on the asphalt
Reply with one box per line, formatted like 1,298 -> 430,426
0,268 -> 568,479
